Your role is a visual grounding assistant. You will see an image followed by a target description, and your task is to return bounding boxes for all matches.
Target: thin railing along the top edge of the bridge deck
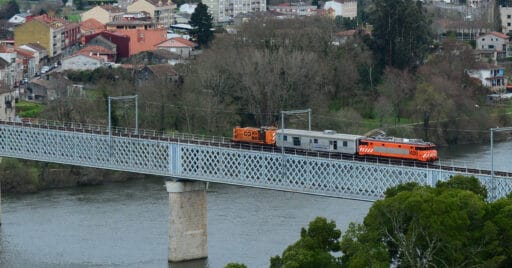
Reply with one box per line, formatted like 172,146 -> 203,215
0,118 -> 500,175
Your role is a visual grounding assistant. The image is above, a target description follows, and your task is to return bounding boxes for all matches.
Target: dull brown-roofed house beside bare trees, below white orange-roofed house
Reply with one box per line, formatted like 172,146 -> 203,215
135,64 -> 180,86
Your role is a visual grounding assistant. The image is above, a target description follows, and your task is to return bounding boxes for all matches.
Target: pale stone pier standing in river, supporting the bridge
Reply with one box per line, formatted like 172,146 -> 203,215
165,180 -> 208,262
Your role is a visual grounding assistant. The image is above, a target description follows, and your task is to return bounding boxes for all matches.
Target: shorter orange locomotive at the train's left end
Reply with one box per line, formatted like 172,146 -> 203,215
233,127 -> 277,145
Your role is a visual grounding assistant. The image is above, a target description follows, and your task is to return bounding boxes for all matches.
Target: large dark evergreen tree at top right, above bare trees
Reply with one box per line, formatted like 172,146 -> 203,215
369,0 -> 431,69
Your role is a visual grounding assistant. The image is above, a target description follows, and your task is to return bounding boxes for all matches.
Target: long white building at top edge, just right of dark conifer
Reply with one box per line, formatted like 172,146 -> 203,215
203,0 -> 267,22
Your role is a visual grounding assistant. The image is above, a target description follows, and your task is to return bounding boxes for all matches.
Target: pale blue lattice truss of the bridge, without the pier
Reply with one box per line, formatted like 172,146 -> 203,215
0,124 -> 512,200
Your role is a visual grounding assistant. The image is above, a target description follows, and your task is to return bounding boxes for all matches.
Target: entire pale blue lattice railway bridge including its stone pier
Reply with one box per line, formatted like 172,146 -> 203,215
0,121 -> 512,262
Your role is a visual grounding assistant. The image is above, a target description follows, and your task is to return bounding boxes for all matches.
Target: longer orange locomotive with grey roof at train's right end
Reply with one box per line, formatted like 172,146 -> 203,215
358,137 -> 438,162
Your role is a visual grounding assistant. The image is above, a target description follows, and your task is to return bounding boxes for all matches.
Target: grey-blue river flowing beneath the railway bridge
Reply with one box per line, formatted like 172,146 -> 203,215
0,142 -> 512,268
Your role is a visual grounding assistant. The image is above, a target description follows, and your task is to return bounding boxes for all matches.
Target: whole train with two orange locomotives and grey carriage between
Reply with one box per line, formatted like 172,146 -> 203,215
232,126 -> 439,162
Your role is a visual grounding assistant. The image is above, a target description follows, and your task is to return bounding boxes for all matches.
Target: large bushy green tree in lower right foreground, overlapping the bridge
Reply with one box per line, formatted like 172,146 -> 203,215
341,176 -> 496,267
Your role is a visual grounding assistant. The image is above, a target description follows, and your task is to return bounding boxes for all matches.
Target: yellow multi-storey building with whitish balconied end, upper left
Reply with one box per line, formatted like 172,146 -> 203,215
14,14 -> 80,57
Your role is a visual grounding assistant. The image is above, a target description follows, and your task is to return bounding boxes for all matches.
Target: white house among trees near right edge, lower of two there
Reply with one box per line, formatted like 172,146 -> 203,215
466,63 -> 508,93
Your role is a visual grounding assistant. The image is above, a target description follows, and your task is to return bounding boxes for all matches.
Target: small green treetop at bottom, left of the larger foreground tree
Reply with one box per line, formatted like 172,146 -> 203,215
270,217 -> 341,268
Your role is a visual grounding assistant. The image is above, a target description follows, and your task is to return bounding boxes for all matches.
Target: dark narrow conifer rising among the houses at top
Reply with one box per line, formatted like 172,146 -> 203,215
190,2 -> 213,47
